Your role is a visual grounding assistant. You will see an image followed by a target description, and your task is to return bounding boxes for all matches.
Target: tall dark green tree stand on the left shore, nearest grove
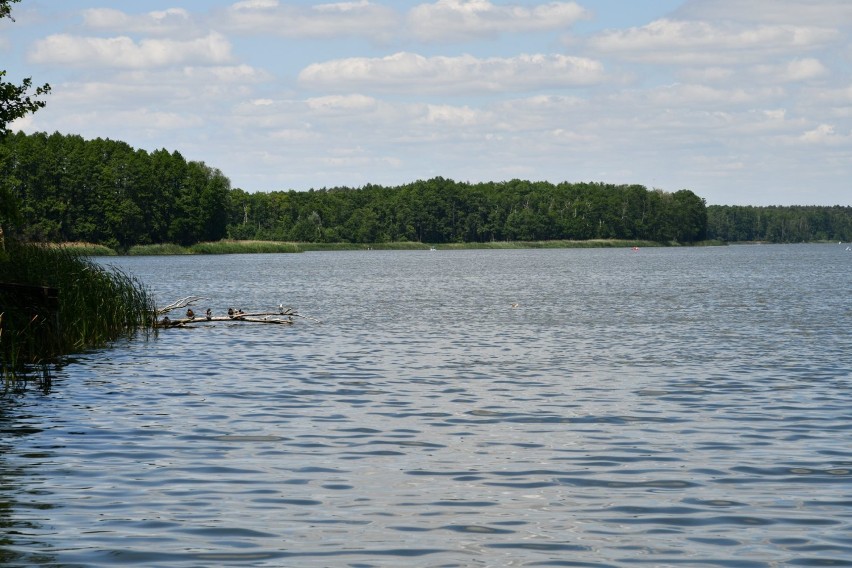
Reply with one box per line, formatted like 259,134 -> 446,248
0,133 -> 231,250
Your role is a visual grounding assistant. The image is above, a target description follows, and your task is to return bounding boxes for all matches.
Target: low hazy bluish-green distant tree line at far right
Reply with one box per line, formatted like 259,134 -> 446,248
707,205 -> 852,243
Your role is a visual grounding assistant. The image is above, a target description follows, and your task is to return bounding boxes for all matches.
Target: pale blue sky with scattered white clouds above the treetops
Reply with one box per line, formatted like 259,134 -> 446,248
0,0 -> 852,206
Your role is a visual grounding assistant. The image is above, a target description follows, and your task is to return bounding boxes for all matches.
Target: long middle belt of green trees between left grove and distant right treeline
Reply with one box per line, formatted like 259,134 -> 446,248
228,177 -> 707,244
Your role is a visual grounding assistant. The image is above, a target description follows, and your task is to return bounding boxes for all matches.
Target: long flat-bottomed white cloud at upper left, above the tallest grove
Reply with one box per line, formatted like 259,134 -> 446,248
29,32 -> 232,69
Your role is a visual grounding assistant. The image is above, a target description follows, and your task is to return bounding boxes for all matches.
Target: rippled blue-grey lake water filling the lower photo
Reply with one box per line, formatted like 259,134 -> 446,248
0,245 -> 852,567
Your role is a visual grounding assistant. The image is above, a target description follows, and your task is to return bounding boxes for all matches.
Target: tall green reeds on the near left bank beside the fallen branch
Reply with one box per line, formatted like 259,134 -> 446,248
0,244 -> 155,388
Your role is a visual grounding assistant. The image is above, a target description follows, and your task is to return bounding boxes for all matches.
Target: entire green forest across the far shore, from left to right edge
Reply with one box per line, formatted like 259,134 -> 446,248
5,132 -> 852,251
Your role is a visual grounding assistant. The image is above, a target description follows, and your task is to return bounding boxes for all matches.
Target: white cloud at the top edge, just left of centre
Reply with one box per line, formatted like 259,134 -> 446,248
219,0 -> 399,40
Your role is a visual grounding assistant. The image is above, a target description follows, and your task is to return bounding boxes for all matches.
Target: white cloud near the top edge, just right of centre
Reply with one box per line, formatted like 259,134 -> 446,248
408,0 -> 590,41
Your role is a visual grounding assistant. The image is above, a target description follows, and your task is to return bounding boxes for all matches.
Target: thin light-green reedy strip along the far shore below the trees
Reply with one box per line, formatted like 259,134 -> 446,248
46,239 -> 725,256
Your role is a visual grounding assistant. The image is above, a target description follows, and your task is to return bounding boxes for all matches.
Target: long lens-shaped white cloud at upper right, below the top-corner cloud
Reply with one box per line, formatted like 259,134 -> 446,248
589,19 -> 841,65
